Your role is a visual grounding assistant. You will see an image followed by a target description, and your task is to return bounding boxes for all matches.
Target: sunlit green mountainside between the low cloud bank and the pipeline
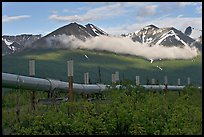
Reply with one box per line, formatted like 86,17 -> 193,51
2,49 -> 202,85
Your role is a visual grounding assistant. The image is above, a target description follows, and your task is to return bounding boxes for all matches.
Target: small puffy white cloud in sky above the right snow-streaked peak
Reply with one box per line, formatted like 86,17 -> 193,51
137,5 -> 158,17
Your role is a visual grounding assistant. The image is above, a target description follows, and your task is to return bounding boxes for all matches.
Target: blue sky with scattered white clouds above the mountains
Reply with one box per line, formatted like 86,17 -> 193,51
2,2 -> 202,37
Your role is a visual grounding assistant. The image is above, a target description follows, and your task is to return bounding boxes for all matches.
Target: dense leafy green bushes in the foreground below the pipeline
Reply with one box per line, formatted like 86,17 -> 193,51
2,85 -> 202,135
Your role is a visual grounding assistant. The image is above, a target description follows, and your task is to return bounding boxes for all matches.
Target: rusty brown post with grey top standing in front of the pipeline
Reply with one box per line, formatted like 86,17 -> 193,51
67,60 -> 73,101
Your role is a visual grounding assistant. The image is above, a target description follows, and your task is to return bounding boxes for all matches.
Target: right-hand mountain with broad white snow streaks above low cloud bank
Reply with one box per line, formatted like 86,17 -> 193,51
125,25 -> 195,47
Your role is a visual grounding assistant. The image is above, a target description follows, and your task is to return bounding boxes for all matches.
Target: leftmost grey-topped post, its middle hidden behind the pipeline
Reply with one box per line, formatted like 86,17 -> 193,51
29,59 -> 36,110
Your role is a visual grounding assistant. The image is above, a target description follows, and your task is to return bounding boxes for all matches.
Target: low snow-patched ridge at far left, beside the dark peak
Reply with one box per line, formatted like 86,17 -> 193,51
2,34 -> 41,55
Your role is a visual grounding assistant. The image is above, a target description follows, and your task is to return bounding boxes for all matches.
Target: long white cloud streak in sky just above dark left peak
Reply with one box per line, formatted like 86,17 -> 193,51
49,3 -> 125,22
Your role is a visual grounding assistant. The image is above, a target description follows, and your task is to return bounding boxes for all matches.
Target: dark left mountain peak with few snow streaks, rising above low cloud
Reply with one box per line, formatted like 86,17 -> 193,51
32,23 -> 108,48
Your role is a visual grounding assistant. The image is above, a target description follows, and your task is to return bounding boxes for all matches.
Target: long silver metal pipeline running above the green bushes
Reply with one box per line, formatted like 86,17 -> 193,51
2,73 -> 198,93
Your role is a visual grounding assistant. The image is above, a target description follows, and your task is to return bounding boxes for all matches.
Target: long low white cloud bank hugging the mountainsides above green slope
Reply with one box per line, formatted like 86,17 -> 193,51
47,34 -> 198,59
